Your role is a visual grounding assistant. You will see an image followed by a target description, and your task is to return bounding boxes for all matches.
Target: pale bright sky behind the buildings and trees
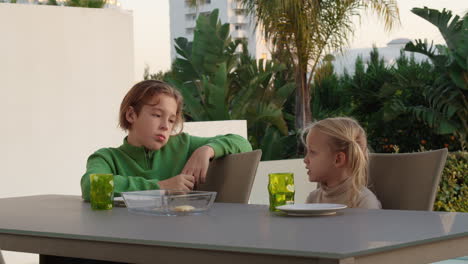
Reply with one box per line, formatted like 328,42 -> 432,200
119,0 -> 468,81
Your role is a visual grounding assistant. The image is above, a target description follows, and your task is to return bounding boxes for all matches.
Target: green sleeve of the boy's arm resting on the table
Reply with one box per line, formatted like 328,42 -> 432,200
81,153 -> 159,202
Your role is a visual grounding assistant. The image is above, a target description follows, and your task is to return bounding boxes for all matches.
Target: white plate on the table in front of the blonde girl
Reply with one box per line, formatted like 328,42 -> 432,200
276,203 -> 347,215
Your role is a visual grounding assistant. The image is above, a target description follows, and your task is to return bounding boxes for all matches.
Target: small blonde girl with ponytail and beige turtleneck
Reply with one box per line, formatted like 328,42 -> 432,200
302,117 -> 381,209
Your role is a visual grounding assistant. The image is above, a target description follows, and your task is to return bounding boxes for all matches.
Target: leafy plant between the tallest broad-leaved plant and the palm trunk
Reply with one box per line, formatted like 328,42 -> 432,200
230,48 -> 297,160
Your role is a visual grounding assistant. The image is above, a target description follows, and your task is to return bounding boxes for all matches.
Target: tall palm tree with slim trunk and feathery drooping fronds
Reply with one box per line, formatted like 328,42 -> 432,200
238,0 -> 399,130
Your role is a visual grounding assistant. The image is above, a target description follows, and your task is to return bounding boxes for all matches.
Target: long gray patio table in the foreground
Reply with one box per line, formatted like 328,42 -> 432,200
0,195 -> 468,264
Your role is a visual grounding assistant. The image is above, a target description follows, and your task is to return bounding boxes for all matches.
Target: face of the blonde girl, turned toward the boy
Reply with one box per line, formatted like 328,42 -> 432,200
304,128 -> 337,183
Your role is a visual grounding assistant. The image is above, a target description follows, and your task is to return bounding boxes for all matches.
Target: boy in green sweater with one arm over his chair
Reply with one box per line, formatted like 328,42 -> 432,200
81,80 -> 252,201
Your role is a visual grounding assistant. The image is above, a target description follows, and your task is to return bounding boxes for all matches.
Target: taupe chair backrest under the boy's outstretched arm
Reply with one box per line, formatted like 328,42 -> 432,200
196,150 -> 262,203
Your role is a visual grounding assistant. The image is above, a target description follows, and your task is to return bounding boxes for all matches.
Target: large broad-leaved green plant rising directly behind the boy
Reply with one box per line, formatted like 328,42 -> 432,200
168,9 -> 240,120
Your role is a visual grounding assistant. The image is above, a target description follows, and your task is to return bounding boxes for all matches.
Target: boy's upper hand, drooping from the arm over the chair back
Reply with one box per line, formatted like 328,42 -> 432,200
182,146 -> 214,184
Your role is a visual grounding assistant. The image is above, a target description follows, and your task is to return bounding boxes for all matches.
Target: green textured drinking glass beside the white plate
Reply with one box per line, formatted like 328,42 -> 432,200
268,172 -> 295,211
